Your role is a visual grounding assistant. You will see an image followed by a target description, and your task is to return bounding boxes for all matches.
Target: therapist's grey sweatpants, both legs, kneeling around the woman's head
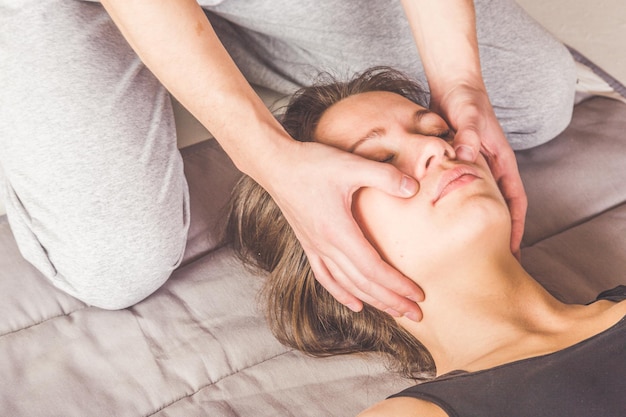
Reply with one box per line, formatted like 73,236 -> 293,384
0,0 -> 575,309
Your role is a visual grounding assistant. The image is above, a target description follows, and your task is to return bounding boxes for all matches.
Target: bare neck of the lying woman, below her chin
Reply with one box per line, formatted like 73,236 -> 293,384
399,250 -> 604,375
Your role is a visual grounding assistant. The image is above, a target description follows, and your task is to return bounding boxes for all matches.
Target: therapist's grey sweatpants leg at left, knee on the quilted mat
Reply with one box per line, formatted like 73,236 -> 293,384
0,0 -> 189,309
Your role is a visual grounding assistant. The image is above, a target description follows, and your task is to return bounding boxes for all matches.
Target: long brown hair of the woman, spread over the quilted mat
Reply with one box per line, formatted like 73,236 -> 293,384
226,67 -> 435,380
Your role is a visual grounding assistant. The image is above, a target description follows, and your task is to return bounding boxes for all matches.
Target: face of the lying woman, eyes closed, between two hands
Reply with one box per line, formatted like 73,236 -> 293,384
314,91 -> 510,277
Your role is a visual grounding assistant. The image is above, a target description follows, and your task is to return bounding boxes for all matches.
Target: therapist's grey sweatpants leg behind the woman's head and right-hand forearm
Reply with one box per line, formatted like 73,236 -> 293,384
200,0 -> 576,149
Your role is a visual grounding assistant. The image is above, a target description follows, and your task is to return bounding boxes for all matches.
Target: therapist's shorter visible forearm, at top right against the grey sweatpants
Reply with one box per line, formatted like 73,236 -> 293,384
402,0 -> 483,100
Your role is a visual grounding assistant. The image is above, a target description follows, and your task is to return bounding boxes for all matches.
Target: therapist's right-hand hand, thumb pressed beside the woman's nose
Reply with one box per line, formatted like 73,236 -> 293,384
435,85 -> 528,259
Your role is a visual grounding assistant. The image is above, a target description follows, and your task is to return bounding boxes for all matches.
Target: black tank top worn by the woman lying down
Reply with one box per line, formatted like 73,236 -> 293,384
390,285 -> 626,417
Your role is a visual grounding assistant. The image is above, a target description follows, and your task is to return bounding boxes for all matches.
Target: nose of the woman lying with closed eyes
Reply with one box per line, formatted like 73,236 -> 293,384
400,135 -> 456,181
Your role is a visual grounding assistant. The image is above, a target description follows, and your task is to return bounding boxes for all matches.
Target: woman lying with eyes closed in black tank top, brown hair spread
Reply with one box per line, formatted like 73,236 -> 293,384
229,68 -> 626,417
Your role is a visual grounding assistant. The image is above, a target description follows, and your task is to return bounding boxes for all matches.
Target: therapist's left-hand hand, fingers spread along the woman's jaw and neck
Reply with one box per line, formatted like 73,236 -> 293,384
265,141 -> 424,321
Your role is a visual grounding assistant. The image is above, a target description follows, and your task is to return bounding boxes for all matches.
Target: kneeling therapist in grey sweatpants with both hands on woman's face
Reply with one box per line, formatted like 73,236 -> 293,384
0,0 -> 575,312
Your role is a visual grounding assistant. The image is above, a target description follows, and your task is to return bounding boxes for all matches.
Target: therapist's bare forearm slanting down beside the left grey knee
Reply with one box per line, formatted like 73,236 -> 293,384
102,0 -> 287,176
